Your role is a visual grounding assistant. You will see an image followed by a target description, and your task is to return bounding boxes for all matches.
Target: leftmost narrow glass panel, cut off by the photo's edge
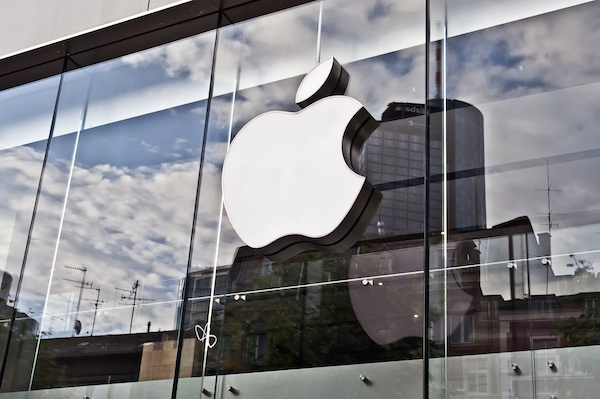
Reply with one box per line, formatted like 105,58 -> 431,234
0,77 -> 60,391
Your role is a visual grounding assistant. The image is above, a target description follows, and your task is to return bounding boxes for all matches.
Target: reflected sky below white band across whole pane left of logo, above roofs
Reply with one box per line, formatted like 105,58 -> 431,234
12,102 -> 206,337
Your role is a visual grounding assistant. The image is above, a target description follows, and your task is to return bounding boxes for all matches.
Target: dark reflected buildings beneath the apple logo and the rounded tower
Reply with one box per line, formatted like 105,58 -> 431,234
177,217 -> 600,371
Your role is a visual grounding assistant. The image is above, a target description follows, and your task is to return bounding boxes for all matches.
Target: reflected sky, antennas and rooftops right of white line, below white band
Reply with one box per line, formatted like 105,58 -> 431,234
27,97 -> 211,388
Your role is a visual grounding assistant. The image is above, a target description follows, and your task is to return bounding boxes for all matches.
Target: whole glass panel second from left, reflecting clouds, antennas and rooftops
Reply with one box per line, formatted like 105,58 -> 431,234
0,32 -> 215,397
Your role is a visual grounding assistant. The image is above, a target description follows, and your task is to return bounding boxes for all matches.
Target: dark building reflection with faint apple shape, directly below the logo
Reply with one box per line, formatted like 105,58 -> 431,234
213,247 -> 422,373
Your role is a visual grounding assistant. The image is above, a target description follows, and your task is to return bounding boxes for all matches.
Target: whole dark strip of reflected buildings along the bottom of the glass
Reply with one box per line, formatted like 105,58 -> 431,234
10,217 -> 600,397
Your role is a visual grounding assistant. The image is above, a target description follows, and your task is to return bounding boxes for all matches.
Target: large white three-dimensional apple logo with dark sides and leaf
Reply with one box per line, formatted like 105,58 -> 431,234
222,57 -> 382,261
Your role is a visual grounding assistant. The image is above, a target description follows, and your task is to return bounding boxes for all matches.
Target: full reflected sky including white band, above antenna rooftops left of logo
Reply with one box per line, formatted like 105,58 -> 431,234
17,32 -> 215,337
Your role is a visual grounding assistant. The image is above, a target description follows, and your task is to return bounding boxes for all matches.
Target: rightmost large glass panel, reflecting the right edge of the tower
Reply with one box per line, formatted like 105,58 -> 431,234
438,0 -> 600,398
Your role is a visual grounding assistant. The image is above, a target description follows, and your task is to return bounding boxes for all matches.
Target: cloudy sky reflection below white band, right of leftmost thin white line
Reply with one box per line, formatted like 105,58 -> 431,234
40,102 -> 206,333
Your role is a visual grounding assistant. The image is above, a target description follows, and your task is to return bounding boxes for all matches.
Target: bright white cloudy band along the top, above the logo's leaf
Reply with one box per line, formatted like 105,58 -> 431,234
203,0 -> 585,98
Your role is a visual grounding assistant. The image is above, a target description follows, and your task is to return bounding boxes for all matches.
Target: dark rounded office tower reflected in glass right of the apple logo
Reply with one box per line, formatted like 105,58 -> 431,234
360,99 -> 486,235
